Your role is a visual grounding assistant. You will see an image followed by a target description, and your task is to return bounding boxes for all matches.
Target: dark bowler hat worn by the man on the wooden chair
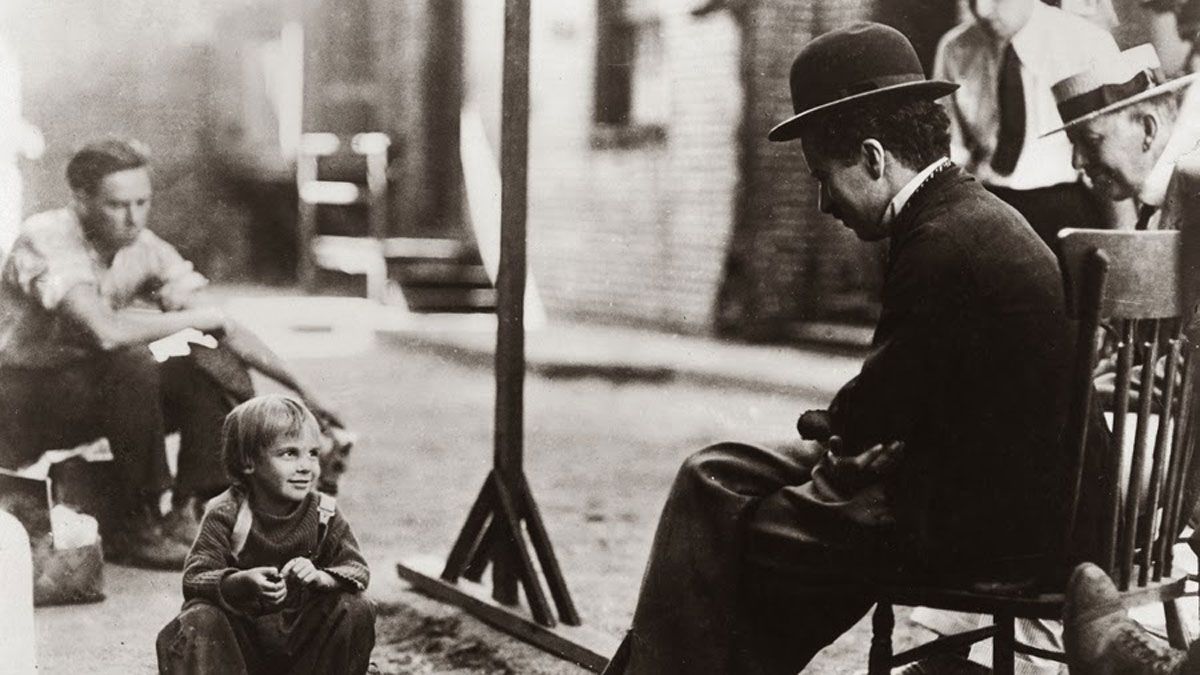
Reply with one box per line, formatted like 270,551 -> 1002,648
767,22 -> 959,141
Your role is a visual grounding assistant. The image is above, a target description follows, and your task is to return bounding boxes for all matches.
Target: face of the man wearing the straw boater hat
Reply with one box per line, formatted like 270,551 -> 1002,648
1067,112 -> 1153,202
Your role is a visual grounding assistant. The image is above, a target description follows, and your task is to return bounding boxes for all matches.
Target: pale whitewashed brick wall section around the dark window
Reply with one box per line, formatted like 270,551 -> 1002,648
466,0 -> 743,331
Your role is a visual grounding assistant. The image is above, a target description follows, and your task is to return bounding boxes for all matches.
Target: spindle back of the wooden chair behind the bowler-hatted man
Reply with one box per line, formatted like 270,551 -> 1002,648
1060,229 -> 1194,590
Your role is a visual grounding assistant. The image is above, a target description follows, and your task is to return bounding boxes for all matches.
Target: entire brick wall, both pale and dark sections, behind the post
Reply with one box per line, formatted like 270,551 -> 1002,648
464,0 -> 956,339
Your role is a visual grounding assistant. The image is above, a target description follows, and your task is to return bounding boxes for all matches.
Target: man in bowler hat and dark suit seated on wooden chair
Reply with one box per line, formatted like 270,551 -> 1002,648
608,23 -> 1072,675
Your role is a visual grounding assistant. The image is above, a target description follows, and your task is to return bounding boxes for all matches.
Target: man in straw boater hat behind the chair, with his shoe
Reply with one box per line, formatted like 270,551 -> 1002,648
1051,44 -> 1200,674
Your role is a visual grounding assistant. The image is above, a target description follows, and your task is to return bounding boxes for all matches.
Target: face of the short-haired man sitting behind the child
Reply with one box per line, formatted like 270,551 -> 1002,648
76,167 -> 154,251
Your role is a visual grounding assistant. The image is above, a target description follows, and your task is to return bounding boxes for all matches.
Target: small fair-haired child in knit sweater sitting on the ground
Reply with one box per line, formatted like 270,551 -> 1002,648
156,395 -> 374,674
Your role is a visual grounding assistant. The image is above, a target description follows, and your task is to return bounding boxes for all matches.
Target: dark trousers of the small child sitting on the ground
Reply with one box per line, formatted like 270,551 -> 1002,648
155,592 -> 374,675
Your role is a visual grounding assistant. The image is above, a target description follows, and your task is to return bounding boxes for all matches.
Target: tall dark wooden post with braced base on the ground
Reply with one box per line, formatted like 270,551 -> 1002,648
396,0 -> 597,671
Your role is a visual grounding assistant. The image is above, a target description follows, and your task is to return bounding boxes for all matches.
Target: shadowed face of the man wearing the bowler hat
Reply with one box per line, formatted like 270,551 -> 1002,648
800,139 -> 888,241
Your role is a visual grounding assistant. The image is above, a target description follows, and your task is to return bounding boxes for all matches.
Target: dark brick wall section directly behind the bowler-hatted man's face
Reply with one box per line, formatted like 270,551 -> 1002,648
716,0 -> 954,339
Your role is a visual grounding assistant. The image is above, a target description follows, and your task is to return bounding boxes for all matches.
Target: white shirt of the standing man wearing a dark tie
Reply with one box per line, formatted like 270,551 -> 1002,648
934,2 -> 1117,190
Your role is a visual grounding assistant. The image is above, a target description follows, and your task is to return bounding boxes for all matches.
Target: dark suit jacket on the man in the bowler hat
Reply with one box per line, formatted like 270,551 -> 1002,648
829,166 -> 1073,566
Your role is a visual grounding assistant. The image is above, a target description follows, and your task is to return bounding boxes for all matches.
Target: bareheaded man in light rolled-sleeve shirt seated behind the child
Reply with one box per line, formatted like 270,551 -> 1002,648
0,141 -> 340,569
